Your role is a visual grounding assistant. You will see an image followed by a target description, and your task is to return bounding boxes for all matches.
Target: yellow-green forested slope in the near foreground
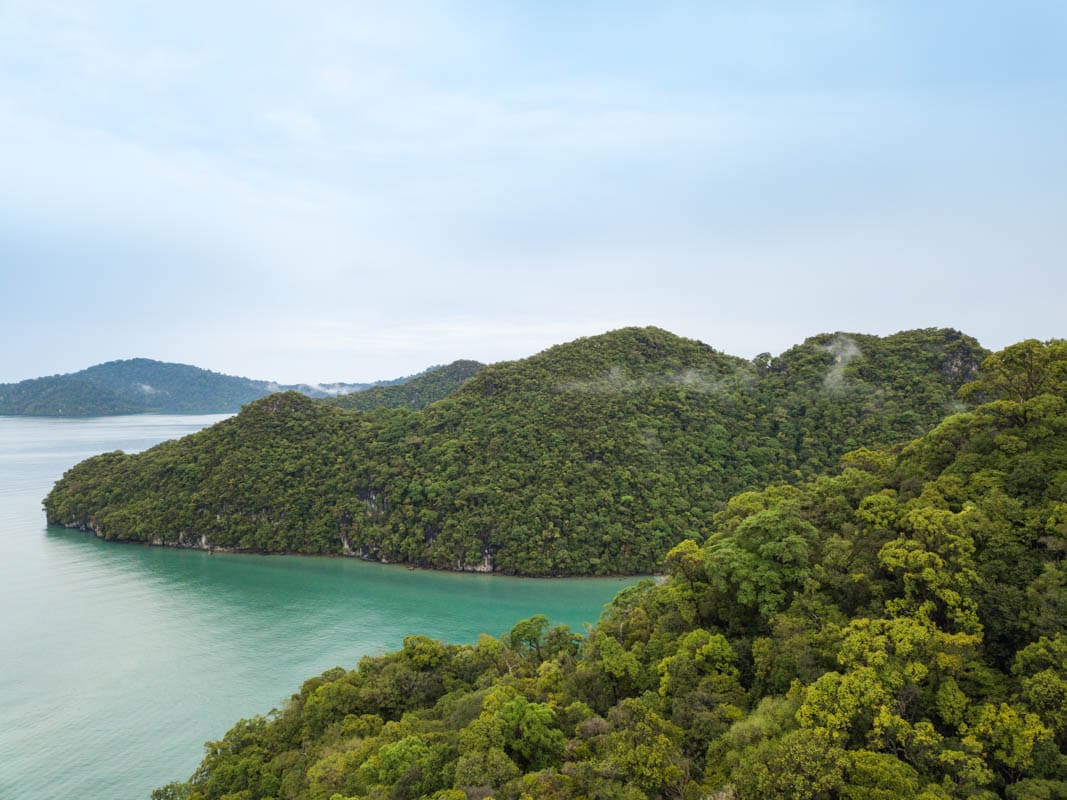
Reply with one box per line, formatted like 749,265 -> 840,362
154,341 -> 1067,800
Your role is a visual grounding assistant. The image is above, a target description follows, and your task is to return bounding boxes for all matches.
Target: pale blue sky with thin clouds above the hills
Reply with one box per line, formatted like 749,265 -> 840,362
0,0 -> 1067,383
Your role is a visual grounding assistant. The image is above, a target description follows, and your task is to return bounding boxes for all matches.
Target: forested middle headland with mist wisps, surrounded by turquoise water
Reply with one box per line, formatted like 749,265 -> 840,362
45,327 -> 986,575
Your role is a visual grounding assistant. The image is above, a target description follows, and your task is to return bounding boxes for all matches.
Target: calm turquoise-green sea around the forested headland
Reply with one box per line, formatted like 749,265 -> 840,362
0,415 -> 633,800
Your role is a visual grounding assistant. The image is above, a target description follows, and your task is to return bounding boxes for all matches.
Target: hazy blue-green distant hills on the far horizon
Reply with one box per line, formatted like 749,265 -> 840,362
0,358 -> 405,417
